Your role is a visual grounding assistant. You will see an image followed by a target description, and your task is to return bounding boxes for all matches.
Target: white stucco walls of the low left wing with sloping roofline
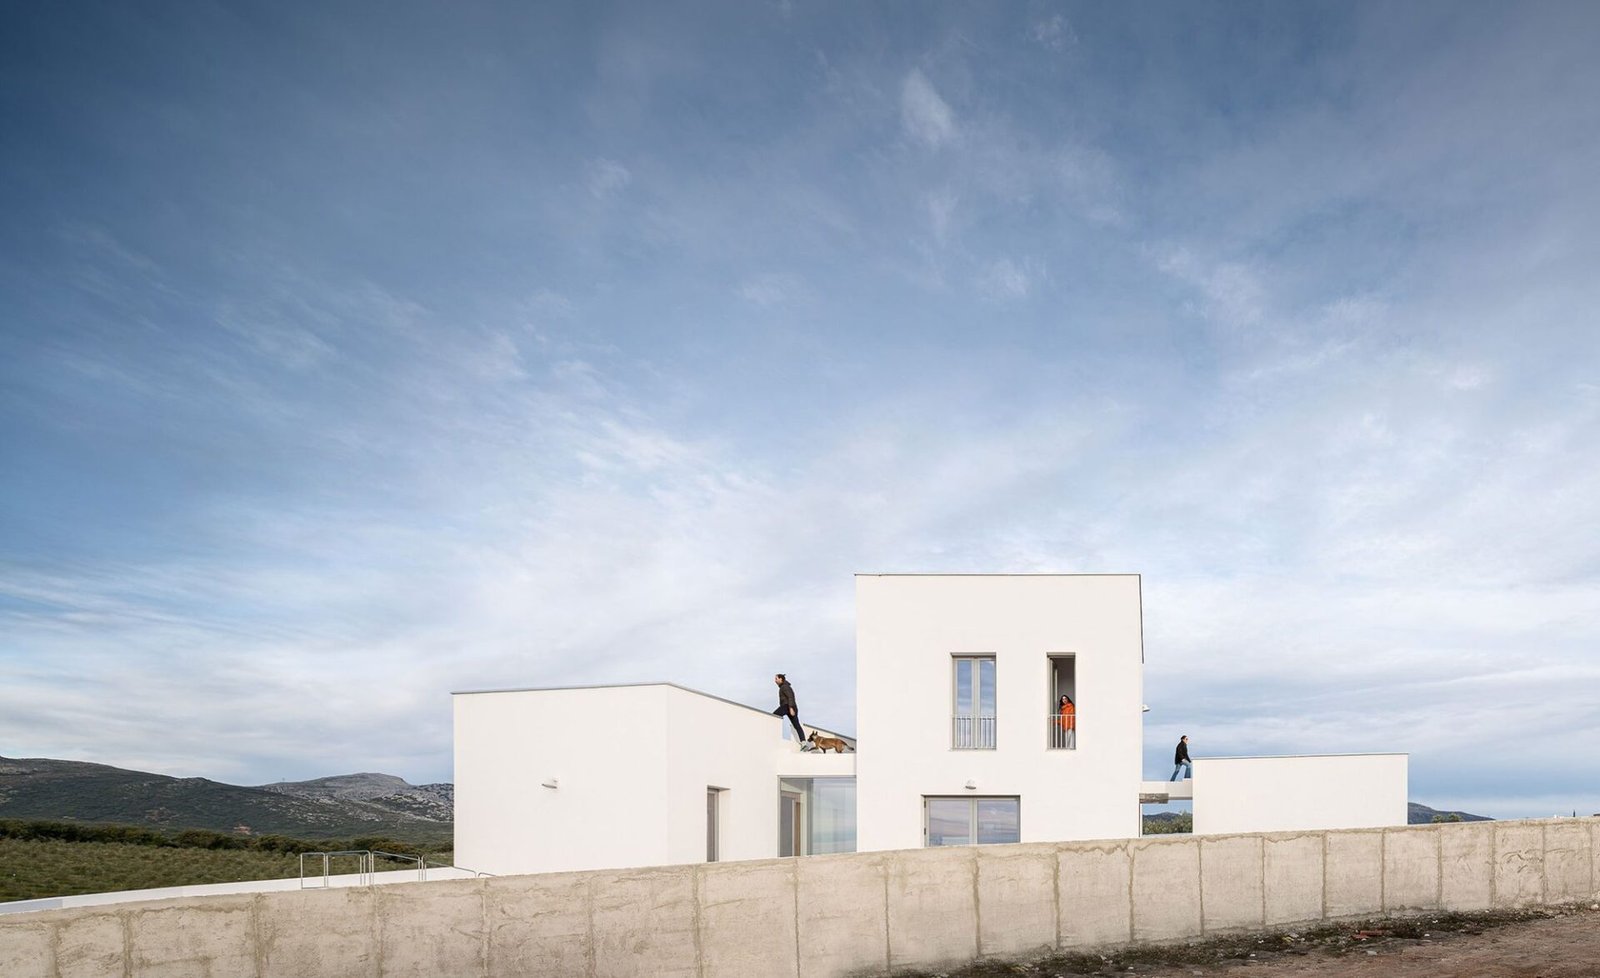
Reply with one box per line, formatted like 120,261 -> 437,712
454,683 -> 794,874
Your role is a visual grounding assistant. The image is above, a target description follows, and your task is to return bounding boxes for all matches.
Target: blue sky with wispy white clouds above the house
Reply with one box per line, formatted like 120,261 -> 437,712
0,0 -> 1600,816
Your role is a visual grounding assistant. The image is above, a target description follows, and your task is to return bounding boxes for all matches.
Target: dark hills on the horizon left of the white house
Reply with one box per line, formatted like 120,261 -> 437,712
0,757 -> 454,842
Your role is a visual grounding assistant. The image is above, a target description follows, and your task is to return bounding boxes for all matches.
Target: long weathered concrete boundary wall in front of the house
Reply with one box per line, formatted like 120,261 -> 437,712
0,818 -> 1600,978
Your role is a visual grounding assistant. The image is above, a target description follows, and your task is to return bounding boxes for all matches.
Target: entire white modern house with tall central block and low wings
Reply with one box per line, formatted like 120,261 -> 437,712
454,575 -> 1406,874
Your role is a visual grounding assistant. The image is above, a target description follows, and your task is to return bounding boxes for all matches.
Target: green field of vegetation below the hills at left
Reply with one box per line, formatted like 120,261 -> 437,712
0,820 -> 450,901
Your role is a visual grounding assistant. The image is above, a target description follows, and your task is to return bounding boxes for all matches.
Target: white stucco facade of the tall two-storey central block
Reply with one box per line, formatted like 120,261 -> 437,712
856,575 -> 1144,852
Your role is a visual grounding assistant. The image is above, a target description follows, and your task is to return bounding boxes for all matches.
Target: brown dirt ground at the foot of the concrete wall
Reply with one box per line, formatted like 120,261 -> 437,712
915,904 -> 1600,978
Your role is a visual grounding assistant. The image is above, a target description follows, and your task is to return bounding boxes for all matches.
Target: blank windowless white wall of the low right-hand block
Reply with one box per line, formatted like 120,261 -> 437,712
1194,754 -> 1408,834
